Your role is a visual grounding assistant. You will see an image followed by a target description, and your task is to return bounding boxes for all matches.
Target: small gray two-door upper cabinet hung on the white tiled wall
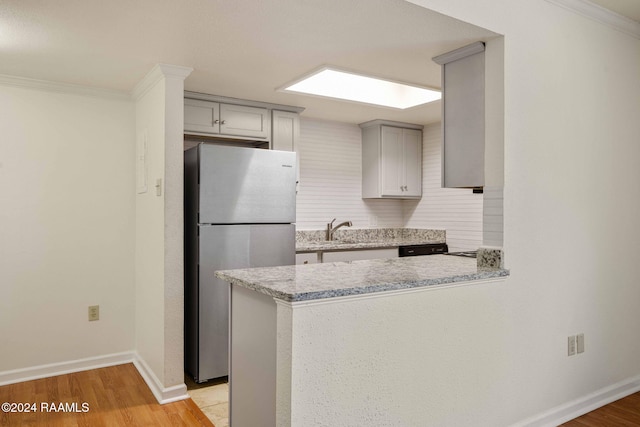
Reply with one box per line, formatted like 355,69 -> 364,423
360,120 -> 422,199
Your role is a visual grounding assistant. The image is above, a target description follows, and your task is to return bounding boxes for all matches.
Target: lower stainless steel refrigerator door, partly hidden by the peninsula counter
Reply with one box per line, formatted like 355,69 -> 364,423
197,224 -> 295,381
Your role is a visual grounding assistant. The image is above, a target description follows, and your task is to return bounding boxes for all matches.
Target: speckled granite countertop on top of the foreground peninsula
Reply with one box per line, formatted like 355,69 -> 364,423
215,255 -> 509,302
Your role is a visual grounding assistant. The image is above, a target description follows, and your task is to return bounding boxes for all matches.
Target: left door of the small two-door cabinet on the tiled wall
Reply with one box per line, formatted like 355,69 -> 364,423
380,126 -> 404,197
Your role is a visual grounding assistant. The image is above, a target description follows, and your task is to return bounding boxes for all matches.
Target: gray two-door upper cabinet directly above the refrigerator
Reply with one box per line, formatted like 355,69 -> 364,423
184,98 -> 271,140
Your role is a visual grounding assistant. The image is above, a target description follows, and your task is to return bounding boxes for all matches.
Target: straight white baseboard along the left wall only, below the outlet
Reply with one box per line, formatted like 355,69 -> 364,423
0,351 -> 134,386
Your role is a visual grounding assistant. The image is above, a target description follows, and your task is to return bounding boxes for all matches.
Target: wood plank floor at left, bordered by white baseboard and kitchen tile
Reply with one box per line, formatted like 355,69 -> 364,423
0,364 -> 213,427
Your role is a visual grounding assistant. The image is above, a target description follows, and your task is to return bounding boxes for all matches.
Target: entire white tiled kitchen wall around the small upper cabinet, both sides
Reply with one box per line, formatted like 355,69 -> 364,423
297,118 -> 483,251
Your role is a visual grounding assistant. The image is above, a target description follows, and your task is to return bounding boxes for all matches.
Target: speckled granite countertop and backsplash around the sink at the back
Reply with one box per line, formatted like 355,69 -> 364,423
296,228 -> 446,253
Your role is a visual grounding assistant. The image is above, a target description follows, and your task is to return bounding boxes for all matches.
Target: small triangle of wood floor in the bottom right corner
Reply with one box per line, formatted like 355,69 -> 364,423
562,393 -> 640,427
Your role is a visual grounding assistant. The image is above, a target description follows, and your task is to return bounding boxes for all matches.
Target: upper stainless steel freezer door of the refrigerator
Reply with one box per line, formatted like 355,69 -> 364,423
199,144 -> 296,224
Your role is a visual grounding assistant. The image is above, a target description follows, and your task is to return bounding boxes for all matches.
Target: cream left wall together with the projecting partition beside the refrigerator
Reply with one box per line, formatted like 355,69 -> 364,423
0,65 -> 191,402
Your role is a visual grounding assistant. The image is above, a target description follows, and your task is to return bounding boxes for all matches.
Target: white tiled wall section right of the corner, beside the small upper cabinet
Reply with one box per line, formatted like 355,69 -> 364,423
403,123 -> 482,252
